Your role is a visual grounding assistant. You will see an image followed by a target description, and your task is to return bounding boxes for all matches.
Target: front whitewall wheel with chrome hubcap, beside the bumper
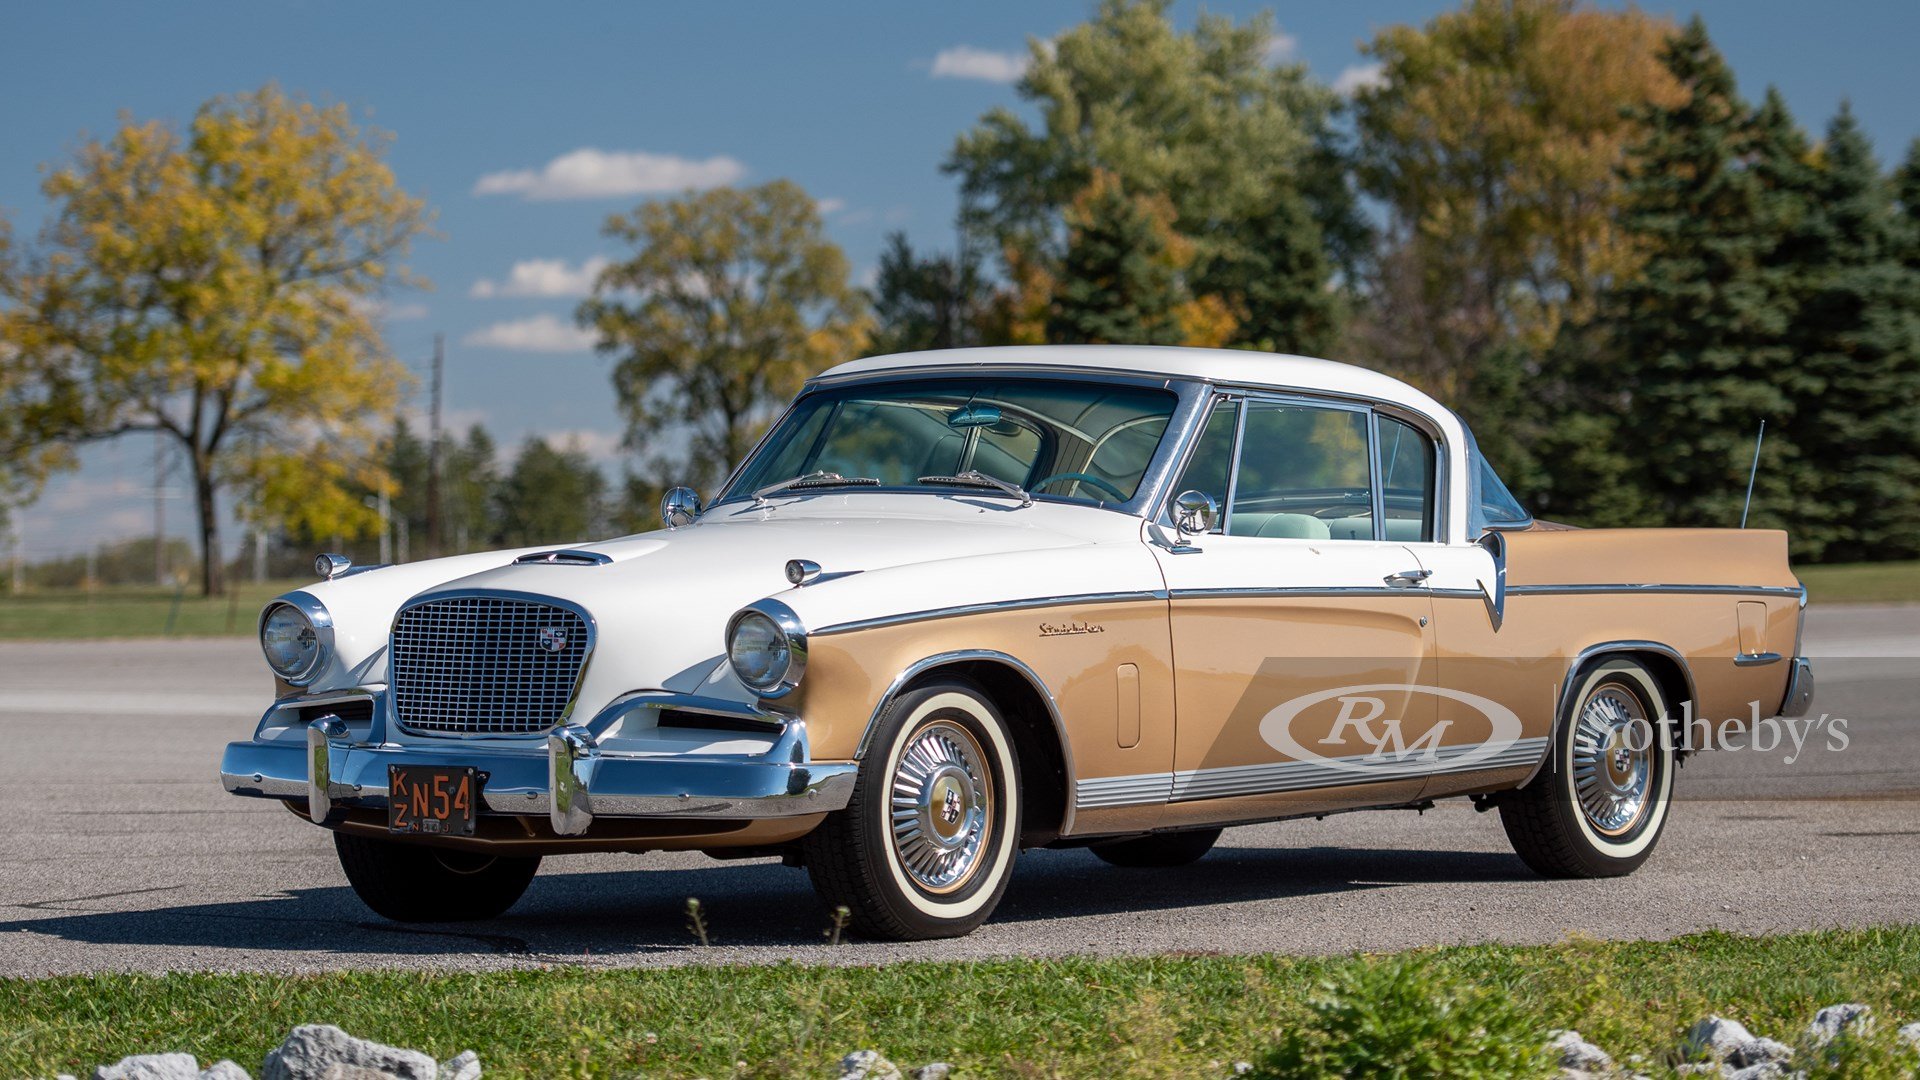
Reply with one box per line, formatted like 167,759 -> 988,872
806,678 -> 1021,940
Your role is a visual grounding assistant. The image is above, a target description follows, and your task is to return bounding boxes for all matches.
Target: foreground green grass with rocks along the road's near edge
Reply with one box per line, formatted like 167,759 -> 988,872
0,926 -> 1920,1078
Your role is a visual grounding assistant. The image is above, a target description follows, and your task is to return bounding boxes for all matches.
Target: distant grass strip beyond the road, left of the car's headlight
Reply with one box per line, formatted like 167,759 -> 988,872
0,582 -> 305,640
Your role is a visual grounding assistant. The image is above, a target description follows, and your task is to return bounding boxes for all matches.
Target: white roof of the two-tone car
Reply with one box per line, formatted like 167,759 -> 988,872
818,346 -> 1453,420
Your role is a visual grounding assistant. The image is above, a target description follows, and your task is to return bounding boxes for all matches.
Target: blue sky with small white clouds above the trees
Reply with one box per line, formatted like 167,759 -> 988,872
0,0 -> 1920,557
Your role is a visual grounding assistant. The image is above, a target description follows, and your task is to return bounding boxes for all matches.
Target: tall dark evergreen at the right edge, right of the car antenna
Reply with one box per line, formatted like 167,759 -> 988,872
1791,106 -> 1920,559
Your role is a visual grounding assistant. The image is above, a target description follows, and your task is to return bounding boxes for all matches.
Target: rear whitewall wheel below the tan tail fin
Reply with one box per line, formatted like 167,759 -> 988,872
1500,659 -> 1674,878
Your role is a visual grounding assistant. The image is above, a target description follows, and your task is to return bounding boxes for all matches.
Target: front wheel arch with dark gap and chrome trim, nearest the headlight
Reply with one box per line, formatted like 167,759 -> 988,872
854,650 -> 1073,847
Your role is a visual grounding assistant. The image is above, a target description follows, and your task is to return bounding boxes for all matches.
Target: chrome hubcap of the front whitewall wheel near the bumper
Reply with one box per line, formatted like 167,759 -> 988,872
891,721 -> 993,894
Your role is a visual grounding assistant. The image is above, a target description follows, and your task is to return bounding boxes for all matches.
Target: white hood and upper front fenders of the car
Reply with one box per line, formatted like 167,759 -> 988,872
309,492 -> 1140,715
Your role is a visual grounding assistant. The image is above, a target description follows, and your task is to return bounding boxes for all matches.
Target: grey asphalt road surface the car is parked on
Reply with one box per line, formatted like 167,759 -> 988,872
0,607 -> 1920,976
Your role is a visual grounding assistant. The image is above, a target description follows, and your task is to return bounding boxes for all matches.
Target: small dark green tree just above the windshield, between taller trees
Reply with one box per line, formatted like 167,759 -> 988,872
868,233 -> 985,354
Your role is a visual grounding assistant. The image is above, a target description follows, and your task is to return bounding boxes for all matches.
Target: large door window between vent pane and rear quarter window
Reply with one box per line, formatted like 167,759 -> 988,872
1227,402 -> 1373,540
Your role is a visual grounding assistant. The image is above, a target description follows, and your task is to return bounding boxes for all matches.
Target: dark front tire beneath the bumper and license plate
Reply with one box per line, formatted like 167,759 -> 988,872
334,832 -> 540,910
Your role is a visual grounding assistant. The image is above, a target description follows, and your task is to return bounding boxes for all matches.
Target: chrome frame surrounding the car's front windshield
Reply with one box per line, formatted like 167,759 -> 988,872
701,363 -> 1210,517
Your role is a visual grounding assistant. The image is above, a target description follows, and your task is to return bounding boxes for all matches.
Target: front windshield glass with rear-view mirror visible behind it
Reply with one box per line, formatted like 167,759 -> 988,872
722,377 -> 1179,503
